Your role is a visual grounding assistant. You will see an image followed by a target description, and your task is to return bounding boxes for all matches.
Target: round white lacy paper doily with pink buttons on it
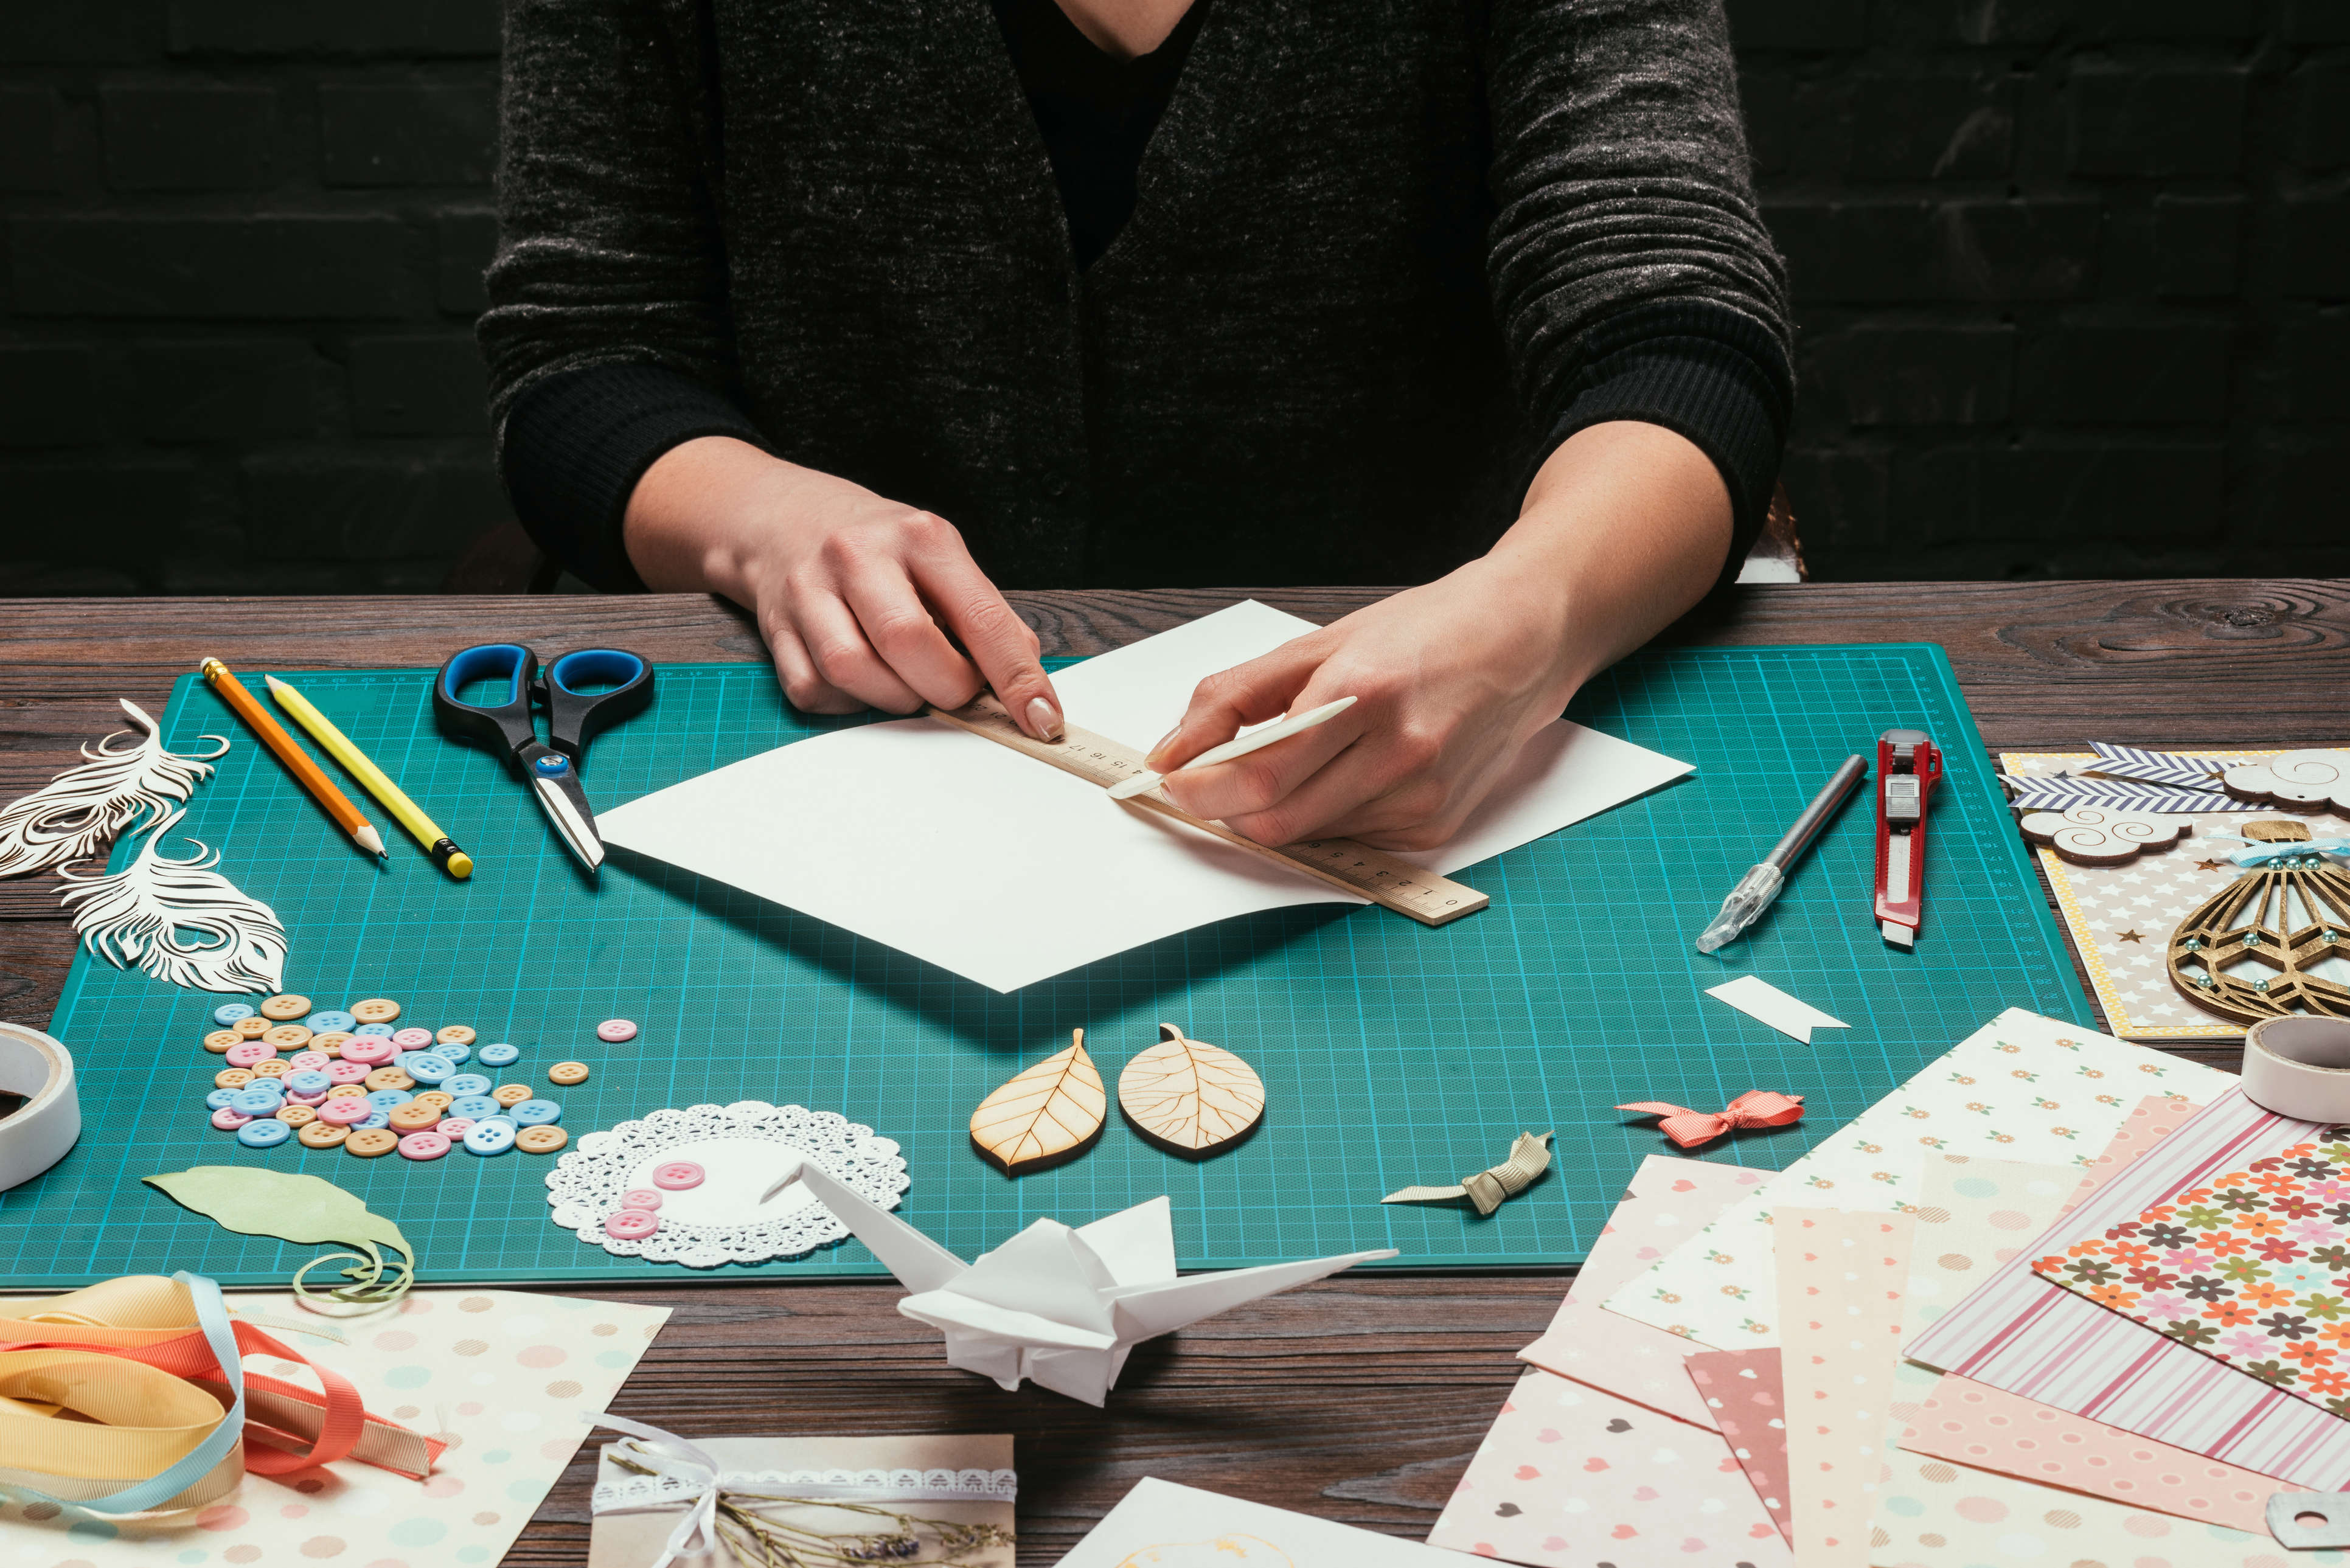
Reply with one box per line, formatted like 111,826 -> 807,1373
548,1100 -> 912,1269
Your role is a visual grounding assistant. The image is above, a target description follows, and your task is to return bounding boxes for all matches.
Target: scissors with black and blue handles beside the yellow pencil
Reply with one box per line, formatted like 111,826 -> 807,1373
433,642 -> 653,870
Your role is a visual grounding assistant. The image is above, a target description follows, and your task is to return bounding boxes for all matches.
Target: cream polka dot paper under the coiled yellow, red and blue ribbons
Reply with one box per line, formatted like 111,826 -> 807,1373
0,1291 -> 670,1568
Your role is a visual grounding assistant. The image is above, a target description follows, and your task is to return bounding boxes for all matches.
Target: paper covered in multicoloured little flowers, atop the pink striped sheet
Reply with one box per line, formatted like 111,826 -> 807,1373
2032,1142 -> 2350,1418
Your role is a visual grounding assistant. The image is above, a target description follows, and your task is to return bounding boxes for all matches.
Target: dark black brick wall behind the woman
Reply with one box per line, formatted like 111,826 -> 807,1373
0,0 -> 2350,592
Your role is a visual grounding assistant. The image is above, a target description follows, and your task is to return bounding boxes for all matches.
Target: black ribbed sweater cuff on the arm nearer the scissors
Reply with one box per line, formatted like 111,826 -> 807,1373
498,364 -> 766,592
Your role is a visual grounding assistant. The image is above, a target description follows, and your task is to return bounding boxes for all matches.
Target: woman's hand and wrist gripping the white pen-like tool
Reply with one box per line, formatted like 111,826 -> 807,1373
1149,421 -> 1729,848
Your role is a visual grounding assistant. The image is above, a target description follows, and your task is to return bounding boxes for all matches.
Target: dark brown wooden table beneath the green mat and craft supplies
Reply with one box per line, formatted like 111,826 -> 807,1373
0,581 -> 2350,1568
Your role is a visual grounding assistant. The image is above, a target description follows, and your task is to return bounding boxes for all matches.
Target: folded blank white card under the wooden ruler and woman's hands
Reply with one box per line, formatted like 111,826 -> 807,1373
597,600 -> 1689,992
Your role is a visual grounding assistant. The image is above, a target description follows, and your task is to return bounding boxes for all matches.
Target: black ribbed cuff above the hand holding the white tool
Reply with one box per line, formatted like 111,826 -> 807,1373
1544,301 -> 1795,581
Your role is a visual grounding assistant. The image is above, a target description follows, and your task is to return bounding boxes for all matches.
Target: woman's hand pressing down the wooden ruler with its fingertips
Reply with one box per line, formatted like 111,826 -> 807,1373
625,435 -> 1062,740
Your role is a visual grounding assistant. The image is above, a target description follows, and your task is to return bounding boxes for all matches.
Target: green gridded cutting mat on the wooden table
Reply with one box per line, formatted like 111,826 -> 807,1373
0,644 -> 2091,1286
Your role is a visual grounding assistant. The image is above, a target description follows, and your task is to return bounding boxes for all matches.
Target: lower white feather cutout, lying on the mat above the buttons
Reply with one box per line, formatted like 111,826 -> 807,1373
59,811 -> 287,992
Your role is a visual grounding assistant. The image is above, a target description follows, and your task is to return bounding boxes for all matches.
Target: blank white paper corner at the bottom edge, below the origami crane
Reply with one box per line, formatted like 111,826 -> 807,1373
1057,1476 -> 1462,1568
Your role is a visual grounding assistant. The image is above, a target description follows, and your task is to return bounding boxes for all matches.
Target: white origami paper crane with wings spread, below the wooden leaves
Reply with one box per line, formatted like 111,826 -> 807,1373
768,1161 -> 1396,1406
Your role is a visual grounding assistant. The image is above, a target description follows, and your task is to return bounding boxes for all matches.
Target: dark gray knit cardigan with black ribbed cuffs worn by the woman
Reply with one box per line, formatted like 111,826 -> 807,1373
479,0 -> 1793,588
